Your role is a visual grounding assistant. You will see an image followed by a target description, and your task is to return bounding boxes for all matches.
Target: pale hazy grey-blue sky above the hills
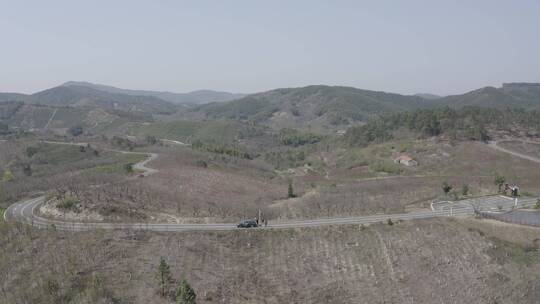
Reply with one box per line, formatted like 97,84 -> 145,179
0,0 -> 540,94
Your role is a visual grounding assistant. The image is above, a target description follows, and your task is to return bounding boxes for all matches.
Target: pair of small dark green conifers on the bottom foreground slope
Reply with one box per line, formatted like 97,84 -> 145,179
156,257 -> 197,304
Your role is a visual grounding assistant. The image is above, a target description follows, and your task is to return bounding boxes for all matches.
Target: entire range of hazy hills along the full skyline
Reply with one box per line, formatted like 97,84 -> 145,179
0,82 -> 540,131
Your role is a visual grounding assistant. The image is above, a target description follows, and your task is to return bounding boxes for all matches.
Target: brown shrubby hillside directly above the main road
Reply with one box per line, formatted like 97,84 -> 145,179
30,139 -> 540,223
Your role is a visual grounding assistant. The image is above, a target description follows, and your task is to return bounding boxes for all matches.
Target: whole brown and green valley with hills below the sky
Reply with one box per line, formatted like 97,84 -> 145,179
0,83 -> 540,303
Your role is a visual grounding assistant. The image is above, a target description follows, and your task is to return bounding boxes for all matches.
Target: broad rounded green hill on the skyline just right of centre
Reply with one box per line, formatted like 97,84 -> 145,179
194,85 -> 439,129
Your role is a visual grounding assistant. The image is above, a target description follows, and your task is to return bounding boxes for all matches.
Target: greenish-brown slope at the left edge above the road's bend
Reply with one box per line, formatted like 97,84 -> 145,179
0,138 -> 146,207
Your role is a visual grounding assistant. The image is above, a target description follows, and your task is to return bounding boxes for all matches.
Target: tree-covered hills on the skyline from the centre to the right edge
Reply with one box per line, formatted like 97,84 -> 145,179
194,83 -> 540,130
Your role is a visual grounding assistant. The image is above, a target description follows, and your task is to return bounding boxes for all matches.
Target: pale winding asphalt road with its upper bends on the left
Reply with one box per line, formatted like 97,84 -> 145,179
4,142 -> 537,231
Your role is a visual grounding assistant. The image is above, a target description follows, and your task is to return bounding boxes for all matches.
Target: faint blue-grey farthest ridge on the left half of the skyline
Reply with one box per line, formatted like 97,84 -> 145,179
61,81 -> 245,104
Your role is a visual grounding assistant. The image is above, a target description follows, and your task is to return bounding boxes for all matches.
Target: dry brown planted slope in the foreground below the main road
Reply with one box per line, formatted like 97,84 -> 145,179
0,219 -> 540,303
